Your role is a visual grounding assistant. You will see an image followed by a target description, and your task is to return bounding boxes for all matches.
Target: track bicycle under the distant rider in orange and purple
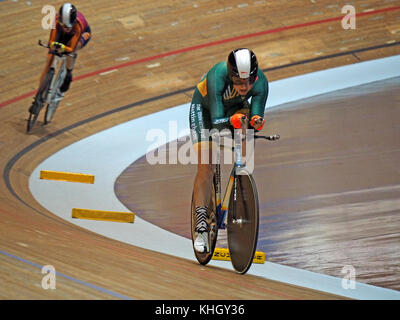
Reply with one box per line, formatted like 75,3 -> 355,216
26,40 -> 76,132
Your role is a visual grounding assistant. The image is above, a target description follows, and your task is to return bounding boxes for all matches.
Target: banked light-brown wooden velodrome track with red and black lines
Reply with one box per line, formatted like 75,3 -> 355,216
0,0 -> 400,299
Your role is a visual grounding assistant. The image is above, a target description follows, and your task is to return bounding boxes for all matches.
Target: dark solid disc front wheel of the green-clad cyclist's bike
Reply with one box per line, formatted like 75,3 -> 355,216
227,169 -> 259,274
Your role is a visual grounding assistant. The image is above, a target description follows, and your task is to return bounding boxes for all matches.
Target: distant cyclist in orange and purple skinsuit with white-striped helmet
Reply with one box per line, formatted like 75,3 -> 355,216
39,3 -> 91,96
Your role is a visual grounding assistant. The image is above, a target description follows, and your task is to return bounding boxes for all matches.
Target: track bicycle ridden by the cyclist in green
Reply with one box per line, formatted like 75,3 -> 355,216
191,117 -> 280,274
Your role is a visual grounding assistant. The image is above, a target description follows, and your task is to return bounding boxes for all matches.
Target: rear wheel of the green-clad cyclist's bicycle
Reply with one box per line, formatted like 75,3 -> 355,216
191,176 -> 218,265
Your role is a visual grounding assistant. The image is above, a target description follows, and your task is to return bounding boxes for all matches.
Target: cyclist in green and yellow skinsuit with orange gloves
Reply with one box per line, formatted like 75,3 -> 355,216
189,48 -> 268,253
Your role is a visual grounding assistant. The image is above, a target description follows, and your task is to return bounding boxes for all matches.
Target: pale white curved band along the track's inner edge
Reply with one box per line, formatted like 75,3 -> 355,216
29,55 -> 400,299
